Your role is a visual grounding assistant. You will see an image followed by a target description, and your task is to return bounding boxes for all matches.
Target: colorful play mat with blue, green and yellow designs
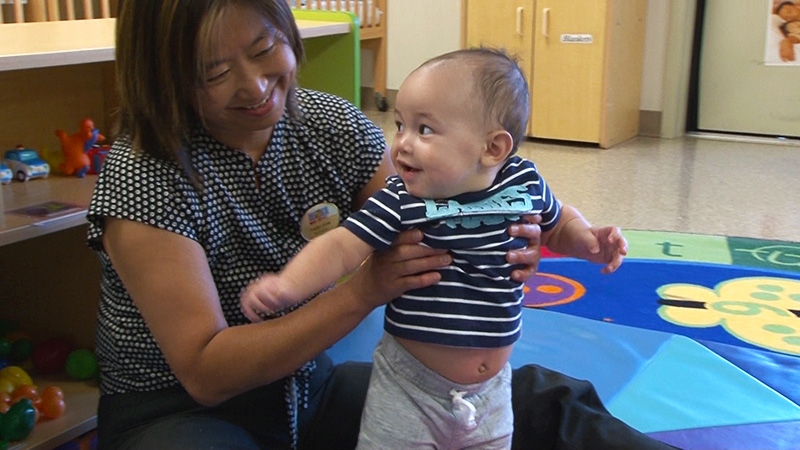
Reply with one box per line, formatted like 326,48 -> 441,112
330,230 -> 800,449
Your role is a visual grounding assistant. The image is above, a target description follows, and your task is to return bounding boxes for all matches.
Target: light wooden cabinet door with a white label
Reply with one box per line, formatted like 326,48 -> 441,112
531,0 -> 607,142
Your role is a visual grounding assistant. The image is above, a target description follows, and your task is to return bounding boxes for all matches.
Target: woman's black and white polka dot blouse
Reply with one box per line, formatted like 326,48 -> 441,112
88,89 -> 385,393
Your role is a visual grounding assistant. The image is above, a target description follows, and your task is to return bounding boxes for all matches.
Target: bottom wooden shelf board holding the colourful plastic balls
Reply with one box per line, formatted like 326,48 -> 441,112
8,377 -> 100,450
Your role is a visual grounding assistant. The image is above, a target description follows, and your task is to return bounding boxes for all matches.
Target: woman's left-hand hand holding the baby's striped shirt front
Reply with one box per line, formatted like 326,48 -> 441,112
348,230 -> 454,308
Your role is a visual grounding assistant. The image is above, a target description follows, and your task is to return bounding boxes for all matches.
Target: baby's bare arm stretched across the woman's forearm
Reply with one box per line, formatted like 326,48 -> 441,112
241,226 -> 373,322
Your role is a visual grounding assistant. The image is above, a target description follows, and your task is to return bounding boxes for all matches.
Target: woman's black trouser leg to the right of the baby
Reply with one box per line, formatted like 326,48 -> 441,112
511,364 -> 675,450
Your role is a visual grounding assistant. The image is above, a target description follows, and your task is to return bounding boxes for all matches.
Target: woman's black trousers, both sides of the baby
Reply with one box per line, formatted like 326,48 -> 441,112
98,356 -> 675,450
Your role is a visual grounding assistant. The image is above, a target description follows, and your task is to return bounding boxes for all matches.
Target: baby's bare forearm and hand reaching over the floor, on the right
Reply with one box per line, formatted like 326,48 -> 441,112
542,205 -> 628,273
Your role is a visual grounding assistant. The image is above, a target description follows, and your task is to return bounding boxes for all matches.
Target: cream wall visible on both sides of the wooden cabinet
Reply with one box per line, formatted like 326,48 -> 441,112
361,0 -> 672,116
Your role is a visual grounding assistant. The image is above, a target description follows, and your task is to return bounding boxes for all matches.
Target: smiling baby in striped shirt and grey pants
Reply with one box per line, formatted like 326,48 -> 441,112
241,48 -> 627,449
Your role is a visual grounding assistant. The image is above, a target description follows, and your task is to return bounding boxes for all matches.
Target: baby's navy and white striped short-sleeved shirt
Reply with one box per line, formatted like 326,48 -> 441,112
343,156 -> 560,348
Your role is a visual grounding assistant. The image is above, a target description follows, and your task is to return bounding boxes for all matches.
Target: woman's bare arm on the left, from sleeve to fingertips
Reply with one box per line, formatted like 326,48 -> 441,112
103,218 -> 450,405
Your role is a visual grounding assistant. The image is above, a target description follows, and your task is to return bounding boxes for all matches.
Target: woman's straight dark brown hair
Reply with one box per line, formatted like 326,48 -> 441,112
116,0 -> 304,186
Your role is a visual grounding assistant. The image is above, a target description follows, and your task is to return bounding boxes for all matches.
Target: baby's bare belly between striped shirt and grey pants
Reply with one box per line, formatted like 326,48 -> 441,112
396,338 -> 514,384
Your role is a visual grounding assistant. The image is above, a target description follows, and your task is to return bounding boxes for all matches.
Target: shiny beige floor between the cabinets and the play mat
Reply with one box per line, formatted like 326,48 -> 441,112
366,110 -> 800,242
